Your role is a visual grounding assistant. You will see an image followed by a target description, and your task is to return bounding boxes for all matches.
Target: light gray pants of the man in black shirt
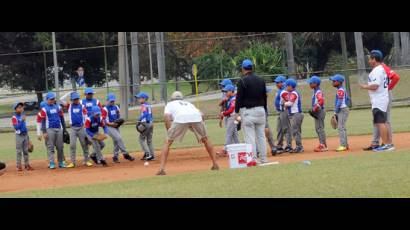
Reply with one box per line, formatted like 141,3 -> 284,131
240,107 -> 268,163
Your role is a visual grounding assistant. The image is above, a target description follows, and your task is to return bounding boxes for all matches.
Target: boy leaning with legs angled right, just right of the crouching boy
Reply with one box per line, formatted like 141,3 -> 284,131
102,93 -> 135,163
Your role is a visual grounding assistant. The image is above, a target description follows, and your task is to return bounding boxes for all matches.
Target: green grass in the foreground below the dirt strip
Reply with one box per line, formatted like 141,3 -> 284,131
4,151 -> 410,198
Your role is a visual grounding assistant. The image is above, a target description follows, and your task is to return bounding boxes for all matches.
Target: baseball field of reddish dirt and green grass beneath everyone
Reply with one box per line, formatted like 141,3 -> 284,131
0,107 -> 410,197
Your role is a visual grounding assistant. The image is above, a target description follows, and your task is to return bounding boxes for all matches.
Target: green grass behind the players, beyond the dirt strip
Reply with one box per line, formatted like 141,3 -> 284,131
0,107 -> 410,161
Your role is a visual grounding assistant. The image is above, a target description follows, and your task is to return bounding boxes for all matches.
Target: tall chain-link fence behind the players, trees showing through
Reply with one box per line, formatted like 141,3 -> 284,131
0,32 -> 410,127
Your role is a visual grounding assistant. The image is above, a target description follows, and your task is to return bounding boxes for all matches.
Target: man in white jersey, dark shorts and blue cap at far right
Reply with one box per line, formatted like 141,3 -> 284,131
360,50 -> 394,152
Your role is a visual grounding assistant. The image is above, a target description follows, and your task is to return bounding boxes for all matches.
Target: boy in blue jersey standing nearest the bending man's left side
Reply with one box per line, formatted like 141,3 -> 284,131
135,92 -> 155,161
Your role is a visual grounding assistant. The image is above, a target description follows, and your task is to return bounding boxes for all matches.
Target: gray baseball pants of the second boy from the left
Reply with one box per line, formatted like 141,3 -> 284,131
47,128 -> 65,162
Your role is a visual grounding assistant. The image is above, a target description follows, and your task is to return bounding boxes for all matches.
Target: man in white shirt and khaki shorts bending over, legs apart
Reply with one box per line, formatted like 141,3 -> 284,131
157,91 -> 219,175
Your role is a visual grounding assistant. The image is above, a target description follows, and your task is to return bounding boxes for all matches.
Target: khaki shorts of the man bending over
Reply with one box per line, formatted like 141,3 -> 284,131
167,122 -> 207,142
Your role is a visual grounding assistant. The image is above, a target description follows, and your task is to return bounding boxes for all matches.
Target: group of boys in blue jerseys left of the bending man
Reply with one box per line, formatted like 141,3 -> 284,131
12,88 -> 155,171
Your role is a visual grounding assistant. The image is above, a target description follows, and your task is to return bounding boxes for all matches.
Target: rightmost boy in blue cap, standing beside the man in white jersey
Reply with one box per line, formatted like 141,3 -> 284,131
330,74 -> 349,152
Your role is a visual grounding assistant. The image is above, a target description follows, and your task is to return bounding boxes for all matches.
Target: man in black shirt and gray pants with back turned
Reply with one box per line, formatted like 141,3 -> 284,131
235,59 -> 268,163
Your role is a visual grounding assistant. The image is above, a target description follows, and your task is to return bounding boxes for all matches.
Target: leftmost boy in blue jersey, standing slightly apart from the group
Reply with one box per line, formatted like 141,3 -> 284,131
11,102 -> 33,171
